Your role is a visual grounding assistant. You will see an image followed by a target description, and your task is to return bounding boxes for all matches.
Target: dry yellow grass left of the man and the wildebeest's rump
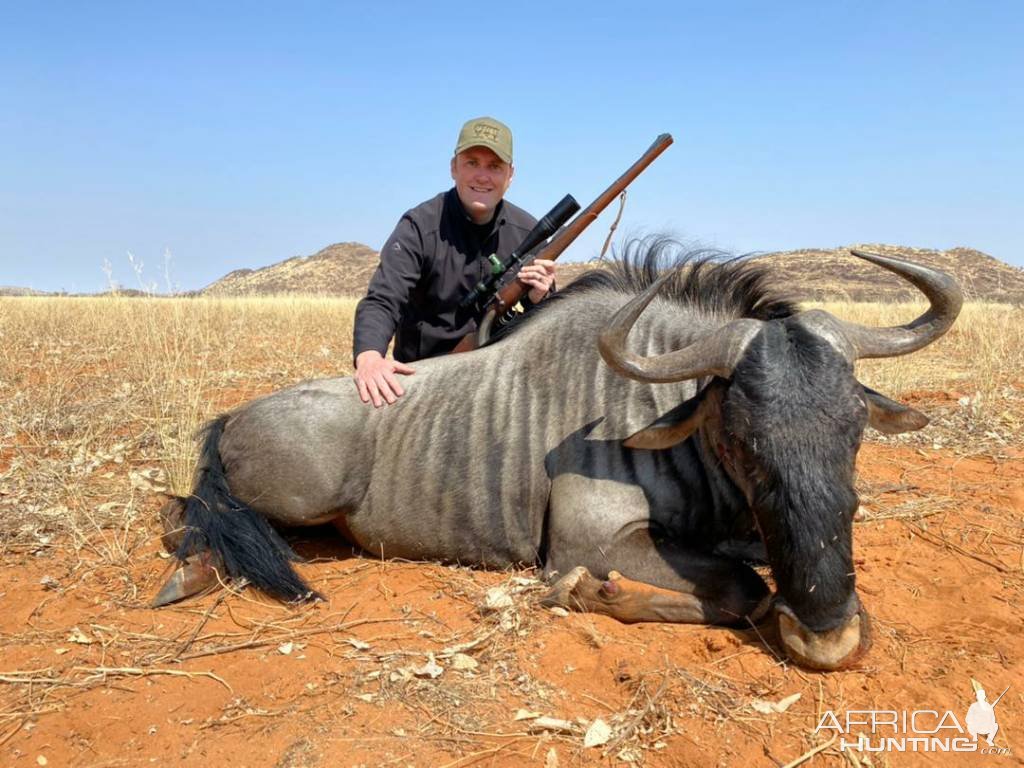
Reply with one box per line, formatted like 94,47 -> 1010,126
0,296 -> 355,561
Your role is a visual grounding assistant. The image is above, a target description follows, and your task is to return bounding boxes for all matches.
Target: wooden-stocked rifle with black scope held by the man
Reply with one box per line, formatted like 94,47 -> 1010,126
452,133 -> 672,353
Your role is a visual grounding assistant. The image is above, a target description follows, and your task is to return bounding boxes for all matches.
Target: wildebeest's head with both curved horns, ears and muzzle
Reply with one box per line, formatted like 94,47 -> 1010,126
600,251 -> 962,670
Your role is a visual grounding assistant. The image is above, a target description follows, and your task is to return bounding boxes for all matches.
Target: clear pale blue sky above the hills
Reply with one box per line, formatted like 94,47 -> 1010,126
0,0 -> 1024,291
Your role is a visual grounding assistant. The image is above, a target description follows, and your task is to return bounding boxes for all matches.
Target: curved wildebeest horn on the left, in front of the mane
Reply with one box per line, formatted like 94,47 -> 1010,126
597,271 -> 761,384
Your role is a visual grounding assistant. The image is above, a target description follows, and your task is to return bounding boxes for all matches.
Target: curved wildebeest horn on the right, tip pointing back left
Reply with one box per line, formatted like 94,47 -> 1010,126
840,250 -> 964,359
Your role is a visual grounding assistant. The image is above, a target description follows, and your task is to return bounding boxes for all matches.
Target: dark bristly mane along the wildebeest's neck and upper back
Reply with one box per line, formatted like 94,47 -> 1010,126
490,237 -> 799,343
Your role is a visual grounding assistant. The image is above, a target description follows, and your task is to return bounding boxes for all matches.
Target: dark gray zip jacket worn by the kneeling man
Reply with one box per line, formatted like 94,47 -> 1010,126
352,187 -> 537,362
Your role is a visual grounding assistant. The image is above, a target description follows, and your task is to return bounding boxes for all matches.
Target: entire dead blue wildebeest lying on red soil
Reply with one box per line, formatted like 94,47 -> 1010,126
157,243 -> 962,669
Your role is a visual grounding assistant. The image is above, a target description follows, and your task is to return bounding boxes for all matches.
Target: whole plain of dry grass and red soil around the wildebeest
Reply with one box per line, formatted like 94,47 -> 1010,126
0,296 -> 1024,768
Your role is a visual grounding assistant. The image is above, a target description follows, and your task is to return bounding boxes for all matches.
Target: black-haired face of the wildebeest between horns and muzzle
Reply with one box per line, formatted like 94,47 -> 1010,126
722,318 -> 867,632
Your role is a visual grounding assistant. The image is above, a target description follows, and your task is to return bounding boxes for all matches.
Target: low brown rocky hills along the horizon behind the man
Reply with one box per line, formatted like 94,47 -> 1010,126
202,243 -> 1024,303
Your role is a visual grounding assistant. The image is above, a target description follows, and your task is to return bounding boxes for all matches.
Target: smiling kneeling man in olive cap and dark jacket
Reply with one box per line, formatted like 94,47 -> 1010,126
352,117 -> 555,408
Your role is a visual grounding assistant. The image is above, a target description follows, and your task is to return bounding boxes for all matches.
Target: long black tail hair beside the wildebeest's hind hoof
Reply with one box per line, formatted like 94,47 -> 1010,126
176,415 -> 319,601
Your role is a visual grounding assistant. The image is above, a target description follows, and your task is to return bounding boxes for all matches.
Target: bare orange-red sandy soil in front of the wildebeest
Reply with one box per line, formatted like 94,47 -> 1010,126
0,443 -> 1024,768
